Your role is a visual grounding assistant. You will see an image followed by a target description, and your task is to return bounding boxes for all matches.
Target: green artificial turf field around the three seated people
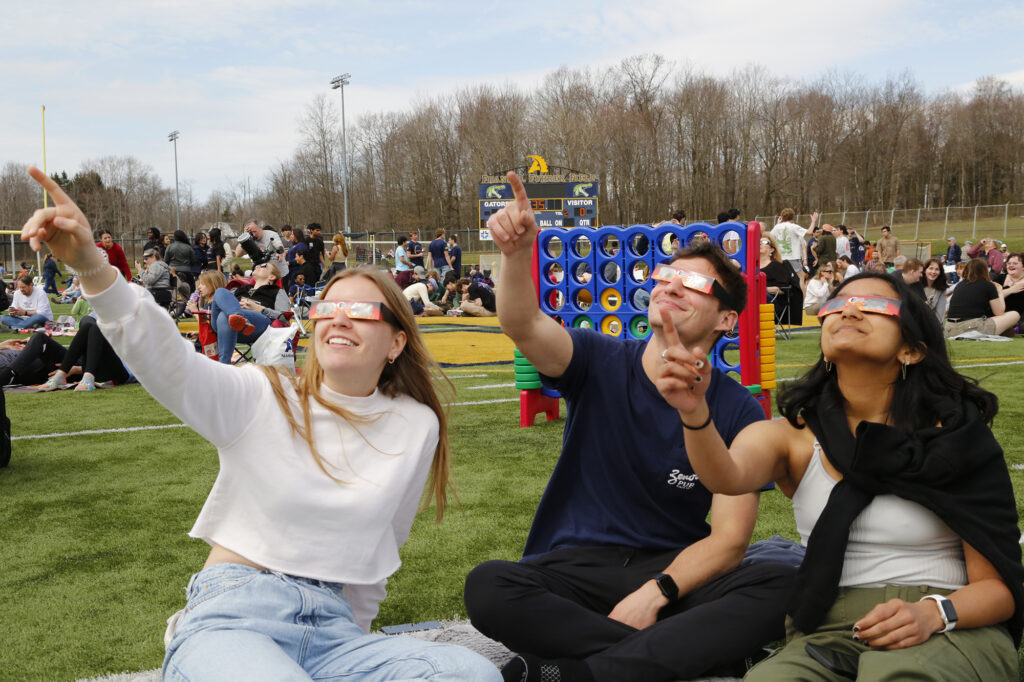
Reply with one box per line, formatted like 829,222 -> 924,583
0,323 -> 1024,681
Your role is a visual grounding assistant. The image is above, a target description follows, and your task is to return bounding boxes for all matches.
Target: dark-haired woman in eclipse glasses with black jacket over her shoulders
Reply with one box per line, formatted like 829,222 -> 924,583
656,273 -> 1024,682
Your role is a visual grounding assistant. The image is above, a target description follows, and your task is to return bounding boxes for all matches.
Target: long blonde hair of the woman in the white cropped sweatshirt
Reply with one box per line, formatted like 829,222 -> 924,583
260,265 -> 454,522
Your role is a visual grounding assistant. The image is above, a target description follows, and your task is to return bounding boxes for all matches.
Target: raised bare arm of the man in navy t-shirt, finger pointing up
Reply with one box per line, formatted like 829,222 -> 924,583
487,172 -> 572,377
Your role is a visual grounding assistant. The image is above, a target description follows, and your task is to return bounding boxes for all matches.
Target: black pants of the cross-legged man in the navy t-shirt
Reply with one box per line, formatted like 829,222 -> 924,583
465,547 -> 796,682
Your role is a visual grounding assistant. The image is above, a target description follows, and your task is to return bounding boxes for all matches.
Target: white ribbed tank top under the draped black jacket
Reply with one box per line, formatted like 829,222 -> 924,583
793,440 -> 967,590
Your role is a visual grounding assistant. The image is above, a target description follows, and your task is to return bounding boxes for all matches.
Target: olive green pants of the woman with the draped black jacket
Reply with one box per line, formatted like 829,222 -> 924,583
743,585 -> 1018,682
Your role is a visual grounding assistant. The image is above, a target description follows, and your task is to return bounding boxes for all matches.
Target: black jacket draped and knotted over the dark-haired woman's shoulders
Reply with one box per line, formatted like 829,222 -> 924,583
790,384 -> 1024,646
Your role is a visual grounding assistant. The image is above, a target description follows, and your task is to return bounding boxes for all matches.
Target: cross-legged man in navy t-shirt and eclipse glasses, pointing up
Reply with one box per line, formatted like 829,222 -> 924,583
465,173 -> 796,682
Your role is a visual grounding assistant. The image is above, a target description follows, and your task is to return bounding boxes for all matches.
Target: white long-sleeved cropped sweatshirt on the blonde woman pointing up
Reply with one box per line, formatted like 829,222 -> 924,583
87,278 -> 438,630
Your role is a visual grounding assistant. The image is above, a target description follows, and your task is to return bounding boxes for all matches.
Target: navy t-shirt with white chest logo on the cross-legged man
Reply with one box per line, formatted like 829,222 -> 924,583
523,329 -> 765,558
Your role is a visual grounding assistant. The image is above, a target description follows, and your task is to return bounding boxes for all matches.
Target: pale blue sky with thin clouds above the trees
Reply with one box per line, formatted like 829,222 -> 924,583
0,0 -> 1024,201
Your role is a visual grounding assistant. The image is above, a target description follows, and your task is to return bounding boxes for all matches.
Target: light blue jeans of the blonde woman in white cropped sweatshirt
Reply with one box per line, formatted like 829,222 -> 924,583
163,563 -> 501,682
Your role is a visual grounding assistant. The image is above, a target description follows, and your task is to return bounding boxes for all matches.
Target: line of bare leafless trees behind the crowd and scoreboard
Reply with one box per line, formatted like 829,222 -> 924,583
0,55 -> 1024,233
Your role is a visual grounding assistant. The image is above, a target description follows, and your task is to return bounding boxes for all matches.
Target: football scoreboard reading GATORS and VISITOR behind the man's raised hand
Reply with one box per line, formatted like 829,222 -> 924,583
478,173 -> 599,230
